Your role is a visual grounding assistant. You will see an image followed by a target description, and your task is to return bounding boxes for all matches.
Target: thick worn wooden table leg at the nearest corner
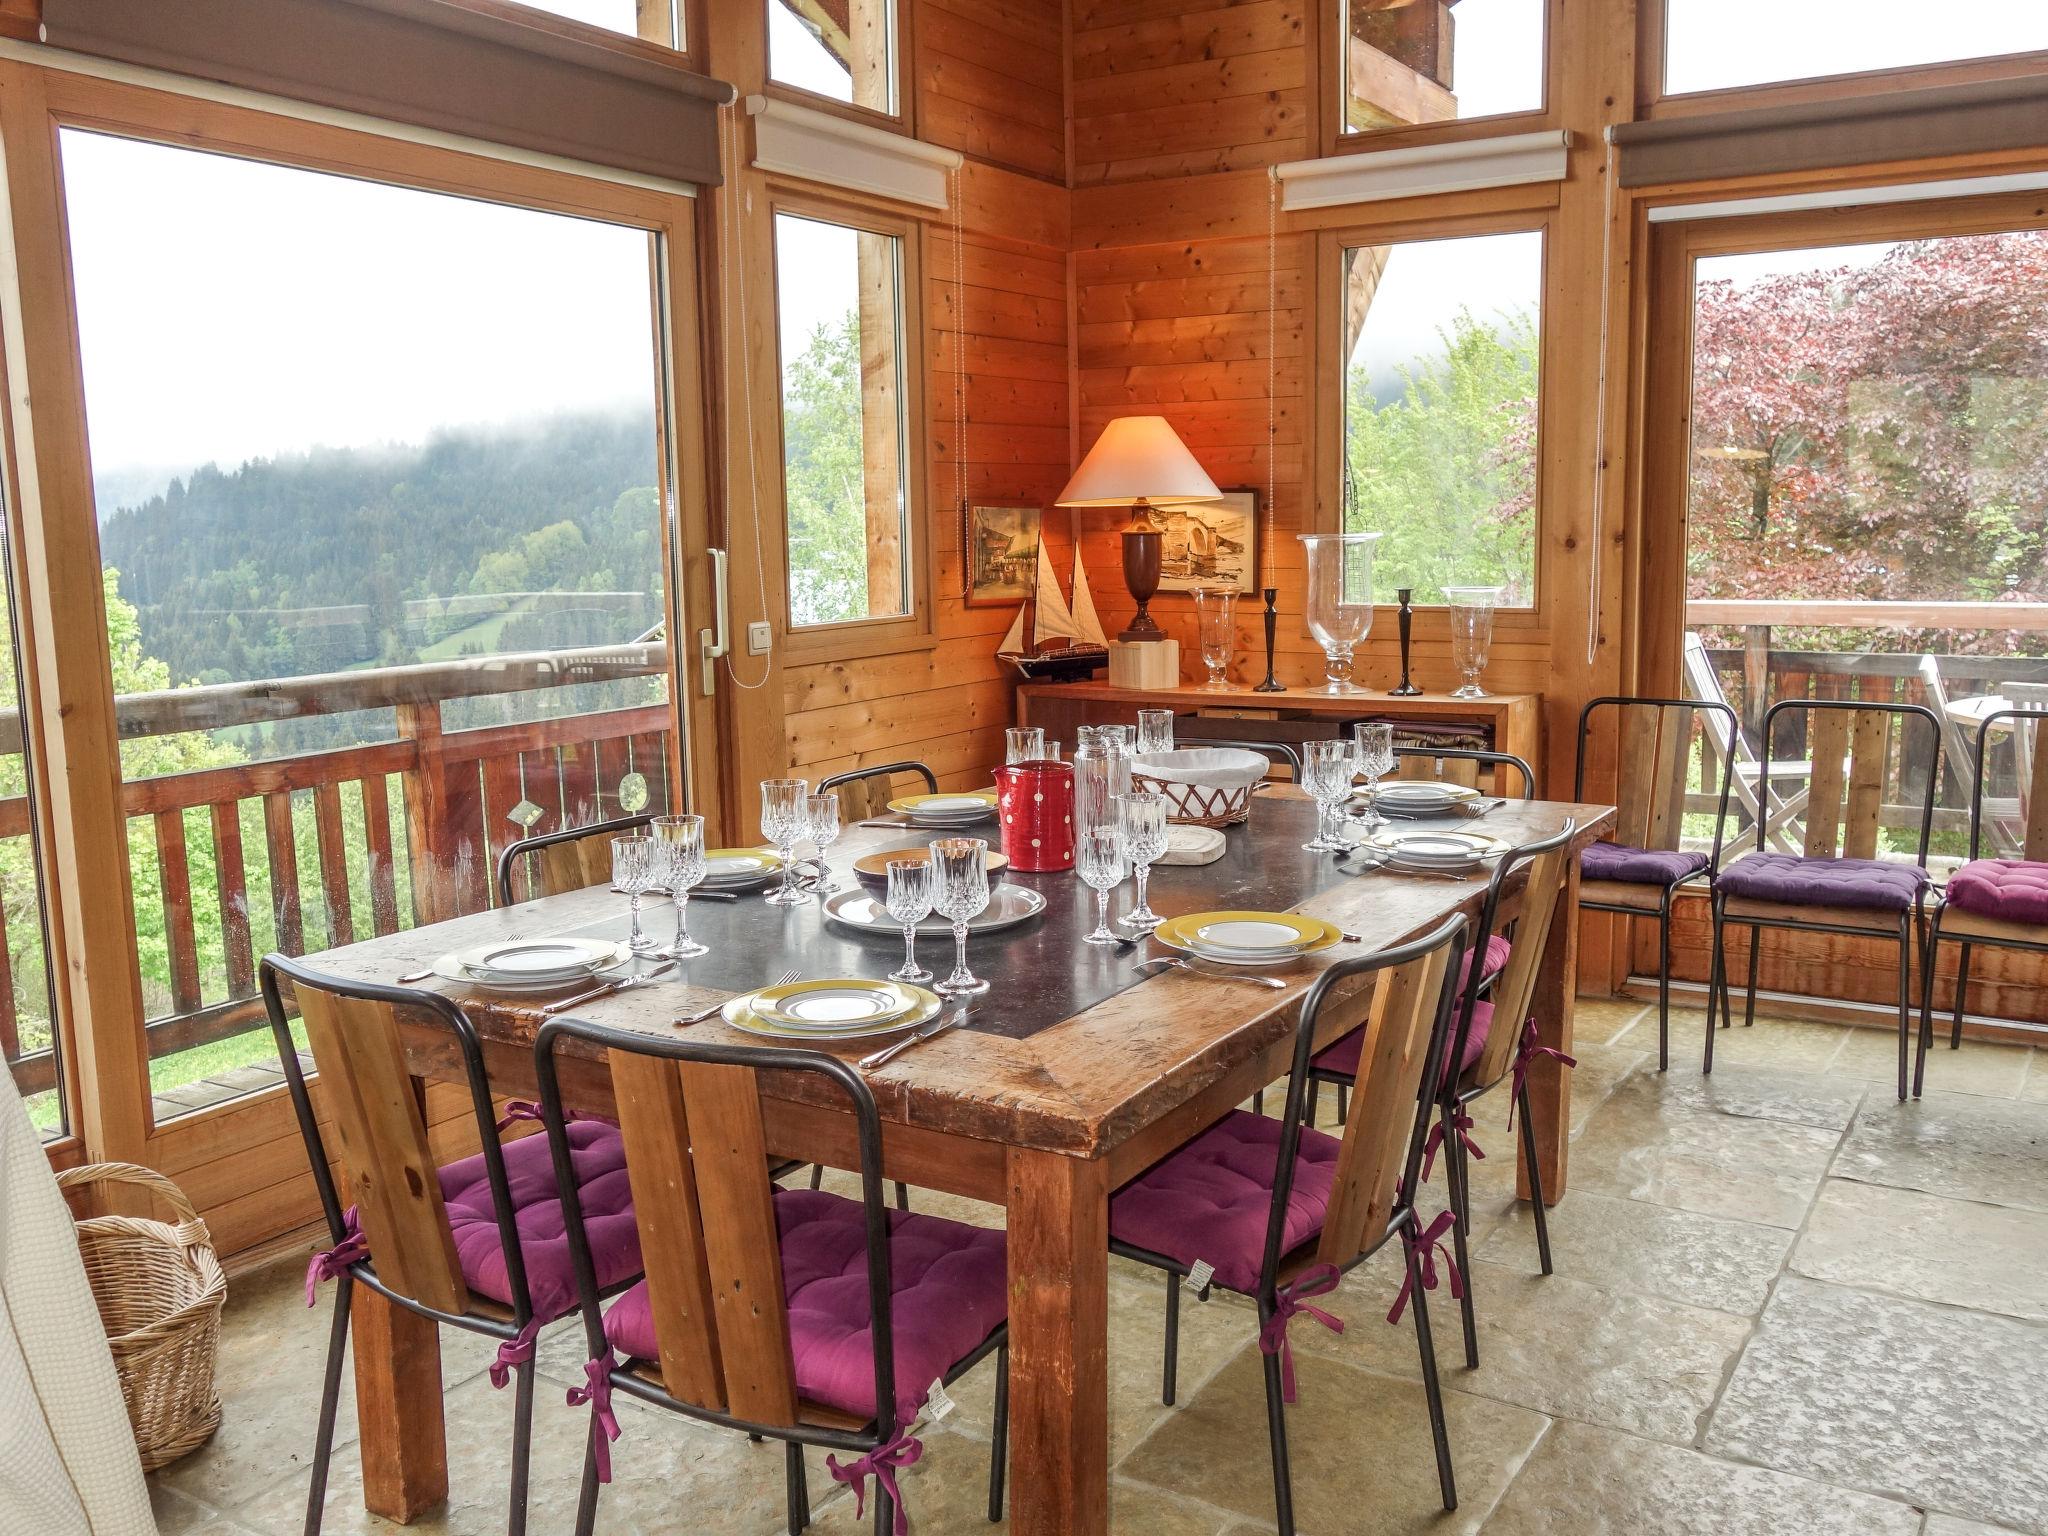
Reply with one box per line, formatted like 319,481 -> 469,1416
1010,1149 -> 1110,1536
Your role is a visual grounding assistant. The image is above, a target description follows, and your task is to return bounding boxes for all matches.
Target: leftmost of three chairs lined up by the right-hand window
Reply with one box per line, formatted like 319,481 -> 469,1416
1571,694 -> 1741,1071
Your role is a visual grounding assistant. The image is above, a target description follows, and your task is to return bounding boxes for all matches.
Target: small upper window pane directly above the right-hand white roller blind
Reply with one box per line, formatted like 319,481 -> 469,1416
1337,0 -> 1544,133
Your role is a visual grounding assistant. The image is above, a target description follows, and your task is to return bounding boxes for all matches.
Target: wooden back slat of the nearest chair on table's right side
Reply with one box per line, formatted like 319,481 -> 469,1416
1317,944 -> 1454,1264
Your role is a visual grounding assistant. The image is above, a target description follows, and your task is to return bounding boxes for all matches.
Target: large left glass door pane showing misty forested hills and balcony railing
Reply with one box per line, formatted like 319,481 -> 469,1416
59,129 -> 672,1118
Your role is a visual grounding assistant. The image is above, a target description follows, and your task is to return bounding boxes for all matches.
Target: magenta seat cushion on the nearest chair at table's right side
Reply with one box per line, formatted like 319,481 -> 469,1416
1110,1110 -> 1341,1294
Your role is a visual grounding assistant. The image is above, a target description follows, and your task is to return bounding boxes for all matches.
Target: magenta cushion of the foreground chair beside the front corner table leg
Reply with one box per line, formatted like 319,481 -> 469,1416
604,1190 -> 1010,1425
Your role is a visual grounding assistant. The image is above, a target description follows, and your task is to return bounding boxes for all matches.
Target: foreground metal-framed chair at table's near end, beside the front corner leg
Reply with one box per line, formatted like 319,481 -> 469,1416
535,1018 -> 1010,1536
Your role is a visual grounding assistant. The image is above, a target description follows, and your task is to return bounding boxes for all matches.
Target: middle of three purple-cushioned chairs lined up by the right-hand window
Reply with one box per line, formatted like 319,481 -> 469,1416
1702,698 -> 1942,1100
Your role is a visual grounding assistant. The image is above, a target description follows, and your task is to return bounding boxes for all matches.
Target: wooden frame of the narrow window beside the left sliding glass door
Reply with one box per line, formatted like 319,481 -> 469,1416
762,185 -> 936,662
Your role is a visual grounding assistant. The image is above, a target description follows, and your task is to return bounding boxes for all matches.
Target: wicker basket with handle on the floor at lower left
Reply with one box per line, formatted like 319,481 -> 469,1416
57,1163 -> 227,1473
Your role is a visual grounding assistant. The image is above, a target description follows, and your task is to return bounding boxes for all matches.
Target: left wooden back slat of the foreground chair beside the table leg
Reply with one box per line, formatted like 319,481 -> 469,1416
610,1051 -> 729,1411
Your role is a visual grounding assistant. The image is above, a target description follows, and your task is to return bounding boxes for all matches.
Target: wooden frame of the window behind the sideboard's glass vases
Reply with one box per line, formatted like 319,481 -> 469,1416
1303,207 -> 1561,645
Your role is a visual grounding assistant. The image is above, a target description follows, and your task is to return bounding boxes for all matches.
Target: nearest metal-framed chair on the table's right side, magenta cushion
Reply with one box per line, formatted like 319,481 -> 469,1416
1110,915 -> 1468,1536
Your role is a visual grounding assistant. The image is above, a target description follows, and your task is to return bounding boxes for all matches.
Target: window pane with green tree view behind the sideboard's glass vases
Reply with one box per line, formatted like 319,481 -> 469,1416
1337,231 -> 1542,606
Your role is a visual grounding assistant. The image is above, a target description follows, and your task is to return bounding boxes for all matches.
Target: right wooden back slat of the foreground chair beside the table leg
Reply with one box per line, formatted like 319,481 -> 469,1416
678,1061 -> 797,1427
